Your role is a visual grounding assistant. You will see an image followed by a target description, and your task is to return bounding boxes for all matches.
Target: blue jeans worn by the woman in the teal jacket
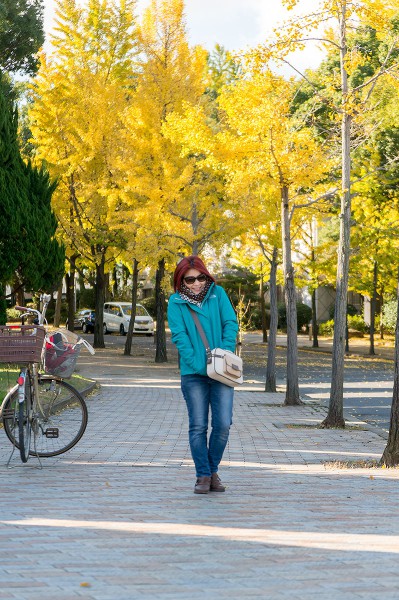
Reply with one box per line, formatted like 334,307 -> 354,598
181,375 -> 234,477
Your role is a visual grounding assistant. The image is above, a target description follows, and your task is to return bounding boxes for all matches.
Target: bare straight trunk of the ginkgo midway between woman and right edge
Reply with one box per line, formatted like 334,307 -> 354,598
281,185 -> 302,406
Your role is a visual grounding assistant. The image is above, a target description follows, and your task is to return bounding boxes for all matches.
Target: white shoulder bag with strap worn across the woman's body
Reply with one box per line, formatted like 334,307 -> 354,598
189,307 -> 244,387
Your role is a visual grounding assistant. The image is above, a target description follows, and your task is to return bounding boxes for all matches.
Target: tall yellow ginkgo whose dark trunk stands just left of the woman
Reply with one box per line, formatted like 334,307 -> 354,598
120,0 -> 236,362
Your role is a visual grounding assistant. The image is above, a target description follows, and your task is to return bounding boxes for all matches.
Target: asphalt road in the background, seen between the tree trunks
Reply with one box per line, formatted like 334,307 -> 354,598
79,334 -> 394,437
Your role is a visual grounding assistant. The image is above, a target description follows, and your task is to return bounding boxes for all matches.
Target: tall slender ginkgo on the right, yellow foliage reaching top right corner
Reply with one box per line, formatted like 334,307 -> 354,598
247,0 -> 399,427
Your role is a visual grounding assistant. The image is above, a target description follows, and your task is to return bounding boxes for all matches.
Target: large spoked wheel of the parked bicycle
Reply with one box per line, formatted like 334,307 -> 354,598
3,376 -> 88,458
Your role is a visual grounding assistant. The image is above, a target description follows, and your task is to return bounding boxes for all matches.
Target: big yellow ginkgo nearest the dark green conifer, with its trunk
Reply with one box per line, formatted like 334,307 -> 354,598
29,0 -> 137,347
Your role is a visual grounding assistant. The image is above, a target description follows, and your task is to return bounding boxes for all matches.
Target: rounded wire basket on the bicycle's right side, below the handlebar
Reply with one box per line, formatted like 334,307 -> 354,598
43,331 -> 81,379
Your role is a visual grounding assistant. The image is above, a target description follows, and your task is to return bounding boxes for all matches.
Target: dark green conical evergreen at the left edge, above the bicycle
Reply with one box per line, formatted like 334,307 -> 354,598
0,76 -> 64,323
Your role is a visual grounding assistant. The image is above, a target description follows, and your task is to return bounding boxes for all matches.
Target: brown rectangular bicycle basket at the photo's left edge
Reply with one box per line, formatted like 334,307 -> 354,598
0,325 -> 46,363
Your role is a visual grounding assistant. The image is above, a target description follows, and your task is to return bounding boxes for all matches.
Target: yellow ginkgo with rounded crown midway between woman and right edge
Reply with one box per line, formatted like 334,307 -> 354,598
162,71 -> 331,404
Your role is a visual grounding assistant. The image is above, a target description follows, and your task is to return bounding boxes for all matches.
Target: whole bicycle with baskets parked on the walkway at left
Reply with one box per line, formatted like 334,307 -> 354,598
0,296 -> 94,466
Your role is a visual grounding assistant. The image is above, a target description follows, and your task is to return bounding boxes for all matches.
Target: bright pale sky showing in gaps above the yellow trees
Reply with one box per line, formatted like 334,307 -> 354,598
44,0 -> 322,68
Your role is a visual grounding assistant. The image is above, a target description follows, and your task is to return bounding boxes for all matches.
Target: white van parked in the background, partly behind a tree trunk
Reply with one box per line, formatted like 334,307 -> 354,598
103,302 -> 154,336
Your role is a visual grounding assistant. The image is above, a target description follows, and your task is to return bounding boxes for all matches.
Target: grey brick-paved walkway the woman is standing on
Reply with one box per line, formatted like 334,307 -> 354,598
0,351 -> 399,600
